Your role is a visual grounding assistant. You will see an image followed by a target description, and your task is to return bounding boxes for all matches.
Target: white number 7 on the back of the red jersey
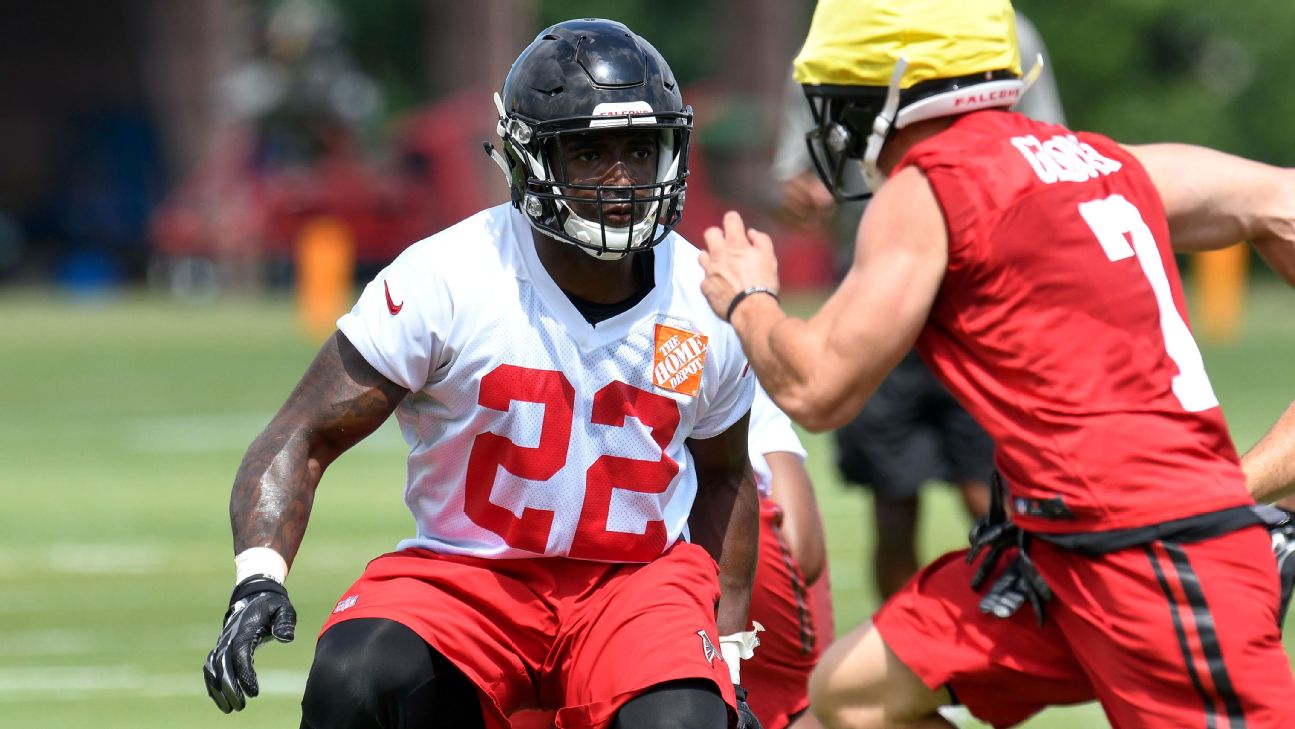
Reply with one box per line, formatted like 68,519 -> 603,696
1079,194 -> 1219,413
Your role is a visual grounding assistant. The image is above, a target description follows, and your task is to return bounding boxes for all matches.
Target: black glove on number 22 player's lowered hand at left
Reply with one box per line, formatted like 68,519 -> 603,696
202,575 -> 297,713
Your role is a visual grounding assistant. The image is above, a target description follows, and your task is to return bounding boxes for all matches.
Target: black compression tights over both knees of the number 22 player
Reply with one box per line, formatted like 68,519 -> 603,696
302,618 -> 728,729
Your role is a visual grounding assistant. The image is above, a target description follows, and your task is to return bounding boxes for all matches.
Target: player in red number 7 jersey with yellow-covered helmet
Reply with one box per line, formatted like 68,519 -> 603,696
702,0 -> 1295,729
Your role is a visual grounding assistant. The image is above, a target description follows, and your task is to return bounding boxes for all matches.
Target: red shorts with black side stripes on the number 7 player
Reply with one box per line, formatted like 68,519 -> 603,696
874,527 -> 1295,729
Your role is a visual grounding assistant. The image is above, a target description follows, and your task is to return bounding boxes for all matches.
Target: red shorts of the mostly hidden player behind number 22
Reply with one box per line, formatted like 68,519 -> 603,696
742,499 -> 831,729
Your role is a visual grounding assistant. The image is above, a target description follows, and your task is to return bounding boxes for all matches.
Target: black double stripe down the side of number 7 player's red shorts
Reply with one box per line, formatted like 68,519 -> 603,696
1145,541 -> 1246,729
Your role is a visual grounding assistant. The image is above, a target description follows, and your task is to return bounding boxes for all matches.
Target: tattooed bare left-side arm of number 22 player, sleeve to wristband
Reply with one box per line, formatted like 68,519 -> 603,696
229,331 -> 408,565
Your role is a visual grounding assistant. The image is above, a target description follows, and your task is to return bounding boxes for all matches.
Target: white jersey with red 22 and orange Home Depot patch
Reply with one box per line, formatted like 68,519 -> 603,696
338,205 -> 755,562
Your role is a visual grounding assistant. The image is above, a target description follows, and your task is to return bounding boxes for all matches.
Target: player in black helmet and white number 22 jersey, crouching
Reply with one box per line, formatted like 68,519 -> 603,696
203,19 -> 759,729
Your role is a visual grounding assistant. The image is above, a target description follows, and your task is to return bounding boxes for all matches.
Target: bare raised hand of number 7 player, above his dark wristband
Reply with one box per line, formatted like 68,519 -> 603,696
701,210 -> 778,319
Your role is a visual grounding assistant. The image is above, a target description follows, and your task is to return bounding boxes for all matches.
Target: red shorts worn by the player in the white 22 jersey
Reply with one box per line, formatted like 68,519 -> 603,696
321,543 -> 736,729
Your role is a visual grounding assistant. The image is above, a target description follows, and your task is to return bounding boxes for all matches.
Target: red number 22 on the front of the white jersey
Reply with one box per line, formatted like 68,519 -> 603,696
464,364 -> 679,562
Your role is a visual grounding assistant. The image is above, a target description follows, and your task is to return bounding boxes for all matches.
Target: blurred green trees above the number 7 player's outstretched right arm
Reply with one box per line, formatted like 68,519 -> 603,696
1015,0 -> 1295,163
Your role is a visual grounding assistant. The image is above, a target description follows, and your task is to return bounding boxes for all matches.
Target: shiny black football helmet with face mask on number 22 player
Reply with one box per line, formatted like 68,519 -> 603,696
484,18 -> 693,259
